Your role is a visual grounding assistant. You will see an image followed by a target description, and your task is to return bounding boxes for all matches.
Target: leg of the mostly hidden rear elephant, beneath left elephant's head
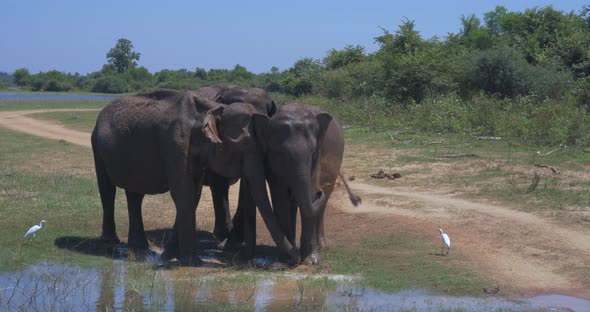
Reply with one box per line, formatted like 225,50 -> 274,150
209,172 -> 233,241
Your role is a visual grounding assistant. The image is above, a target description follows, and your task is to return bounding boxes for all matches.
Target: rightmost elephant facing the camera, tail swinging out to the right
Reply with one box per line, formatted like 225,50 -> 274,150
246,103 -> 360,264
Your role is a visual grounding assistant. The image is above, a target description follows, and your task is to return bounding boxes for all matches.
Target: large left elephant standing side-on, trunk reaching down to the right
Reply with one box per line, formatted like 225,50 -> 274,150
91,89 -> 299,264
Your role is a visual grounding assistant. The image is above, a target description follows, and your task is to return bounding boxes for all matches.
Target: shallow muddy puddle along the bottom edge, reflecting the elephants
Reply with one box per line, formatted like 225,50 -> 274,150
0,262 -> 590,311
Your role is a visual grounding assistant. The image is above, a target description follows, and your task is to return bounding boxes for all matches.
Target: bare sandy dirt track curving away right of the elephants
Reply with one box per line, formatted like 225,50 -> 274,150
344,183 -> 590,298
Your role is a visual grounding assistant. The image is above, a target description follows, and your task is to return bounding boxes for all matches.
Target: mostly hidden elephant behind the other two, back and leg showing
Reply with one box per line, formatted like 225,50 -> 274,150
193,84 -> 277,241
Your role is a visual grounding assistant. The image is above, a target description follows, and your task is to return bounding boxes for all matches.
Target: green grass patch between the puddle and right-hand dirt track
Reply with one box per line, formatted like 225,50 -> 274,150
324,233 -> 491,295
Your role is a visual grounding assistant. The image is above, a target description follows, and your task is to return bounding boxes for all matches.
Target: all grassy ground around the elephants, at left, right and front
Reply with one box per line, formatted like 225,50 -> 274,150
0,101 -> 590,310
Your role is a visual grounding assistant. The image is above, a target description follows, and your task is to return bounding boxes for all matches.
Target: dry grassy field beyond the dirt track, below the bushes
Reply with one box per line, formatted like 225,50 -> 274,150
32,112 -> 590,223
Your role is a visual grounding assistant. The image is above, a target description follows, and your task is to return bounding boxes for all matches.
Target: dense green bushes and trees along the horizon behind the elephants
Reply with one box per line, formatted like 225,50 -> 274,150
8,6 -> 590,145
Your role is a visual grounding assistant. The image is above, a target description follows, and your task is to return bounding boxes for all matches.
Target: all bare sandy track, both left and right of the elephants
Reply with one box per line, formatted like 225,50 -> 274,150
0,109 -> 590,299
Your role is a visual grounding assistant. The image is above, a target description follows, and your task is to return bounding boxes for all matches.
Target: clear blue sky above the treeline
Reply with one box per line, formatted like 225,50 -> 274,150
0,0 -> 587,74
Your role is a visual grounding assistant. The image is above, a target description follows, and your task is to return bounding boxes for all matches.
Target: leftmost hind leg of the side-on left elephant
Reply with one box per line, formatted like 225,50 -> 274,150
94,155 -> 121,244
